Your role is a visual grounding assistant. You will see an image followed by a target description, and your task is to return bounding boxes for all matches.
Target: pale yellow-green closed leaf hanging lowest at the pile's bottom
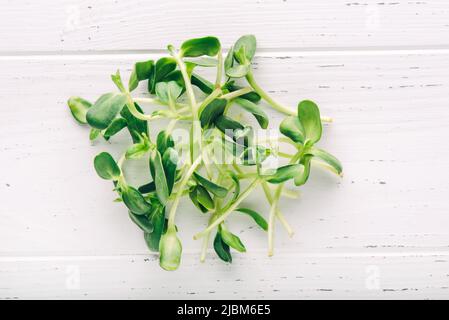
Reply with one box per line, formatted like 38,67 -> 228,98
159,227 -> 182,271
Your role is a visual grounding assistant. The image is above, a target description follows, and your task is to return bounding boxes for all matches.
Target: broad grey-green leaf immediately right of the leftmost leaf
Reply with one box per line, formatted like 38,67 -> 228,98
86,92 -> 127,130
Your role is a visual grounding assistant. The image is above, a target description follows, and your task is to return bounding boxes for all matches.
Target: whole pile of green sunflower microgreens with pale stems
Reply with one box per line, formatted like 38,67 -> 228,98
68,35 -> 342,270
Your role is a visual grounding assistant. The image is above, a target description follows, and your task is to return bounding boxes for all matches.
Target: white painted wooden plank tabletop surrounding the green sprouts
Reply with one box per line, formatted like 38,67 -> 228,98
0,0 -> 449,299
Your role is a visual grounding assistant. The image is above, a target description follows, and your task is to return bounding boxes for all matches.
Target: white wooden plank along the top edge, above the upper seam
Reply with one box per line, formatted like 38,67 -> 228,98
0,0 -> 449,54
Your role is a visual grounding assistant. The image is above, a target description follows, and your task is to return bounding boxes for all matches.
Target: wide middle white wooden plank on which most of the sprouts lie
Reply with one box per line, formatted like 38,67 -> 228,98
0,51 -> 449,264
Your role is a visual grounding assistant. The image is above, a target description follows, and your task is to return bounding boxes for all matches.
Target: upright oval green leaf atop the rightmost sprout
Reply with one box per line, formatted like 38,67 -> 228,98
298,100 -> 323,143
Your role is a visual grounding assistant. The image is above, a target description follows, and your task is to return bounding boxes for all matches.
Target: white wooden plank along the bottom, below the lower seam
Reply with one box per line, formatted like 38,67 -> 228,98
0,252 -> 449,300
